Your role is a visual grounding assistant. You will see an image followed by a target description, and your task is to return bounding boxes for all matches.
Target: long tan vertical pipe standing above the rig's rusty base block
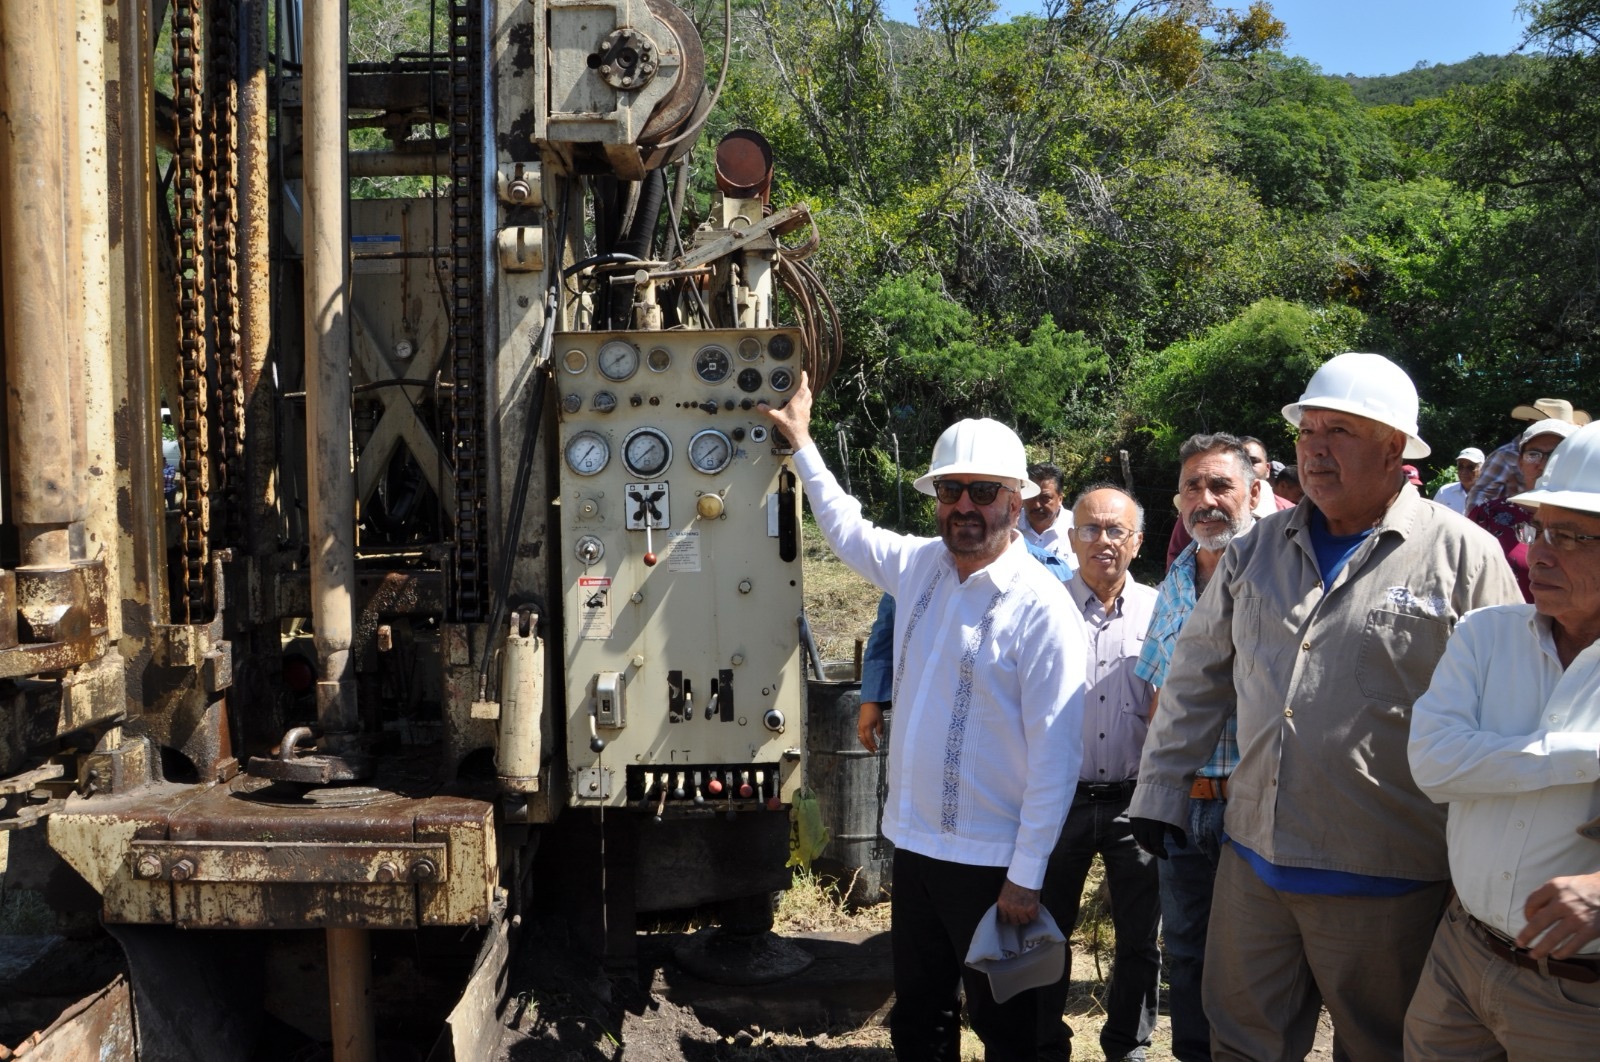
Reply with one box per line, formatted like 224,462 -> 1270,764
302,0 -> 360,738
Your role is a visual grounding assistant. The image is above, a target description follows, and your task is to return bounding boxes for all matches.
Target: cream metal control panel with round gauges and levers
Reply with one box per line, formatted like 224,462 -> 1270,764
554,328 -> 805,816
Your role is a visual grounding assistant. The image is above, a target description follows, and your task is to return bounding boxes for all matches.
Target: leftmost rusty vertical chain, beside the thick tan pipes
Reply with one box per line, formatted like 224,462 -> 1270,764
173,0 -> 211,622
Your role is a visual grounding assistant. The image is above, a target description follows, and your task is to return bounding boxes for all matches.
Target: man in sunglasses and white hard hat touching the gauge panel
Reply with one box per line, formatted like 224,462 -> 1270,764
762,374 -> 1086,1062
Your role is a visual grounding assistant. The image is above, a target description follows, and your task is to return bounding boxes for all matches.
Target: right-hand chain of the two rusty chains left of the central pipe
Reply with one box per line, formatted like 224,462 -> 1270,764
205,0 -> 250,545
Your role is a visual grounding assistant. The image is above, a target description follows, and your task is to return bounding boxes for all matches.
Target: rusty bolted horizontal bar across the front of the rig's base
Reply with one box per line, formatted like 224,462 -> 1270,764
128,840 -> 450,886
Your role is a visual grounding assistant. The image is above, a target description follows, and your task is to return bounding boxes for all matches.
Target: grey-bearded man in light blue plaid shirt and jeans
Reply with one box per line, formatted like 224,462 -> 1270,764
1134,432 -> 1261,1062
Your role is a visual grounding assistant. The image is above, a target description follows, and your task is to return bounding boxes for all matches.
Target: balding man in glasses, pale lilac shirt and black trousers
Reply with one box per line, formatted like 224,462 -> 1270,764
1040,483 -> 1162,1062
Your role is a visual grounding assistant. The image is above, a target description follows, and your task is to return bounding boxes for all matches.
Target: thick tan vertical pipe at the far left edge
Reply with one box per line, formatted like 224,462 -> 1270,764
0,3 -> 83,569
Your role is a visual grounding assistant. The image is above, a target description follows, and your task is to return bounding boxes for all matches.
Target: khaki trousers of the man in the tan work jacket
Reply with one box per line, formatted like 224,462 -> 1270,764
1200,846 -> 1450,1062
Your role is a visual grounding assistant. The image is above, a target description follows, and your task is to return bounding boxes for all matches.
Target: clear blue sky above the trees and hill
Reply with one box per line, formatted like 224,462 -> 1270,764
883,0 -> 1522,77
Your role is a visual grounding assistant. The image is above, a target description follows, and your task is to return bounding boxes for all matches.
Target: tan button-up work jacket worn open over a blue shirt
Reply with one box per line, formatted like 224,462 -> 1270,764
1131,485 -> 1522,881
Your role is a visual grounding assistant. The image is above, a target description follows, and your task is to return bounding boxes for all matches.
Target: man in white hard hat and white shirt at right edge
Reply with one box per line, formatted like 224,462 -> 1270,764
1405,424 -> 1600,1062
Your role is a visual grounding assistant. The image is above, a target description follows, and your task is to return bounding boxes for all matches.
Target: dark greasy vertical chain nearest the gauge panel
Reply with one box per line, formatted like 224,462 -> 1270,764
445,0 -> 488,621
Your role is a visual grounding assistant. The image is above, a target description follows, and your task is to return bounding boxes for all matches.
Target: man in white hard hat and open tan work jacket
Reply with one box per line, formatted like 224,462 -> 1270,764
1133,353 -> 1518,1062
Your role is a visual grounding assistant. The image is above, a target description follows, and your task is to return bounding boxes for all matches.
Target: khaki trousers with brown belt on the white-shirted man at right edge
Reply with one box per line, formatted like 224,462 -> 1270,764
1405,900 -> 1600,1062
